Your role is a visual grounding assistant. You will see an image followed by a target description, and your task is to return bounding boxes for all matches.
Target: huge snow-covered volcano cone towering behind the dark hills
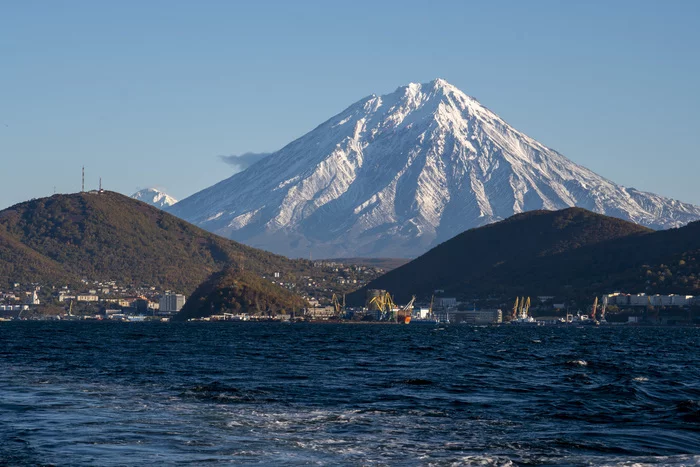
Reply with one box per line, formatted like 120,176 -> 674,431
169,79 -> 700,258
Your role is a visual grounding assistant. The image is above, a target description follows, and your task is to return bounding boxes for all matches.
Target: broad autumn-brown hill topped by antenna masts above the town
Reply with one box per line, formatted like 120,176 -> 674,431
0,192 -> 332,293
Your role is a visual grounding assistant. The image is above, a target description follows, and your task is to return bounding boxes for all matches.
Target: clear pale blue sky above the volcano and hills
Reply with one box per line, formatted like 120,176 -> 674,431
0,0 -> 700,208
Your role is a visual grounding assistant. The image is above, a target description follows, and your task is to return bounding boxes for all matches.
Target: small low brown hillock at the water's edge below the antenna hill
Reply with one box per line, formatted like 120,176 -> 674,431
173,268 -> 307,321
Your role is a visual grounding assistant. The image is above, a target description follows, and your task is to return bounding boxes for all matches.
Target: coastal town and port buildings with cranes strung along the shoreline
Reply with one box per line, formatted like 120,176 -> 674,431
0,274 -> 700,325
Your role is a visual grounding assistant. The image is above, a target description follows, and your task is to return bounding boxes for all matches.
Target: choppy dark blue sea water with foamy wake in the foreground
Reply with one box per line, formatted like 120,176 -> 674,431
0,322 -> 700,466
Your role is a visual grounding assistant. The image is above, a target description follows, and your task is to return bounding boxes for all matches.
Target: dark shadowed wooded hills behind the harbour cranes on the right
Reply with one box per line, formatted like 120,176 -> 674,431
348,208 -> 700,304
